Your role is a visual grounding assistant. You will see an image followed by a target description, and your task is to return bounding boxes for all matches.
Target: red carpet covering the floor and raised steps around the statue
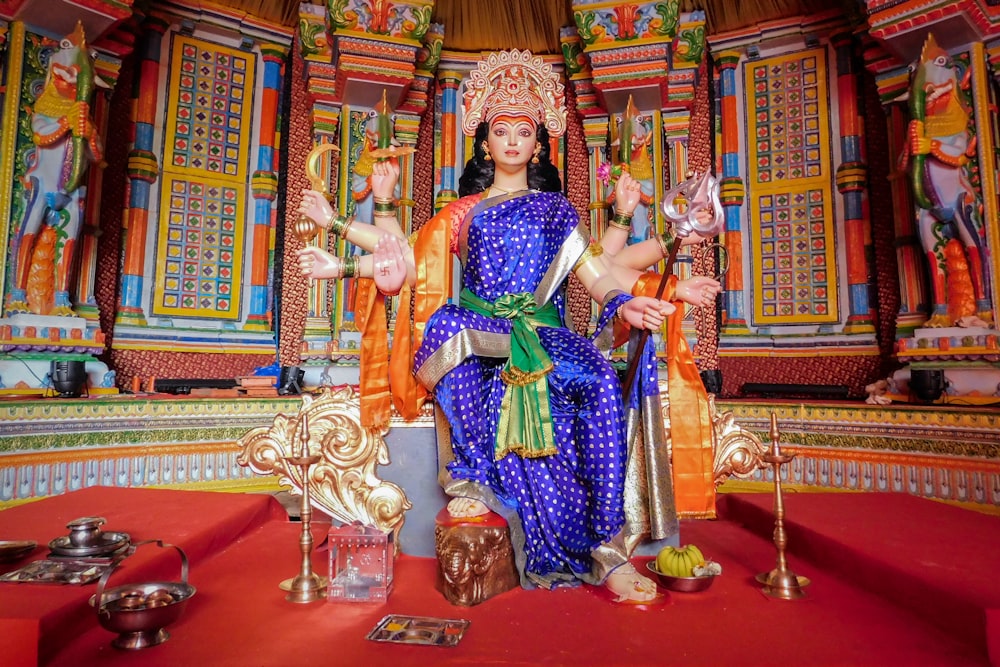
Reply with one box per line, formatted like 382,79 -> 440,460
0,489 -> 1000,667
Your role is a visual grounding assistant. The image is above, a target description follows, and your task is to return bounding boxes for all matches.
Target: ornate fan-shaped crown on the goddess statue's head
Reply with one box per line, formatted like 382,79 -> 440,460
462,49 -> 566,137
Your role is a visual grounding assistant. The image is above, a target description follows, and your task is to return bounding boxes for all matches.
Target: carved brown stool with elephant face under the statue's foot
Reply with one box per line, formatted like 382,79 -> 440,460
434,507 -> 521,607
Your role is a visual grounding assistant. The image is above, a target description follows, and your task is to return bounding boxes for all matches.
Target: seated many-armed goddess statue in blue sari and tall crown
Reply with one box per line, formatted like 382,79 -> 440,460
299,51 -> 719,602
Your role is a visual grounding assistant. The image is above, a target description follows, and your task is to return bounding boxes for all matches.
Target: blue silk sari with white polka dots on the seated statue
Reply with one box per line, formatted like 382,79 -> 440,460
415,192 -> 630,587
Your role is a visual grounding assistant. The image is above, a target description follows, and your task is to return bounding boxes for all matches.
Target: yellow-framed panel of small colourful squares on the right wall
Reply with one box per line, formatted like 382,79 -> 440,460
745,49 -> 837,326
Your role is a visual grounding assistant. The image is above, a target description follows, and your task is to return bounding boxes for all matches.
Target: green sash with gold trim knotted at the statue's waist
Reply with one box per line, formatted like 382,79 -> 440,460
459,288 -> 562,461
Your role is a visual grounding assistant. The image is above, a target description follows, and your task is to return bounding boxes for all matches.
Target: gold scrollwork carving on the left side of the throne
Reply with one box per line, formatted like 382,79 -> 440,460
237,387 -> 411,544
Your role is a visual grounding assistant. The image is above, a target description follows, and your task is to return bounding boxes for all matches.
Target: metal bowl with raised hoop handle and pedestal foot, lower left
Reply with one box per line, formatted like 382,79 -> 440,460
90,540 -> 195,650
